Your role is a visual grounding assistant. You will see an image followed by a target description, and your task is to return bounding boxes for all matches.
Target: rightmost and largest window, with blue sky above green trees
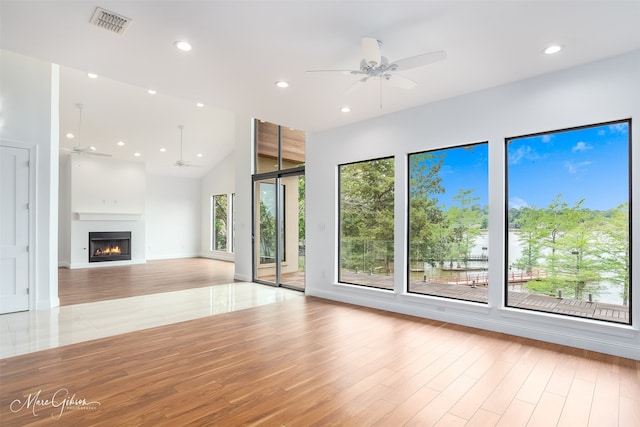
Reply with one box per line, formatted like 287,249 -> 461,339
505,120 -> 632,324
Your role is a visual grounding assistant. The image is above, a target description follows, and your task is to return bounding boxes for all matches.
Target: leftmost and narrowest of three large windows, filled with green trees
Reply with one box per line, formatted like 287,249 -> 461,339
338,158 -> 394,289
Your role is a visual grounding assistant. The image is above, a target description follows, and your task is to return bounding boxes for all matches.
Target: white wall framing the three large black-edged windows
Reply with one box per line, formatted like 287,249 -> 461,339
306,51 -> 640,359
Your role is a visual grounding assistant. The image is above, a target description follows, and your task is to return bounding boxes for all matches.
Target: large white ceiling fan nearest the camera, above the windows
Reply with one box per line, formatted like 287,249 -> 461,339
307,37 -> 447,108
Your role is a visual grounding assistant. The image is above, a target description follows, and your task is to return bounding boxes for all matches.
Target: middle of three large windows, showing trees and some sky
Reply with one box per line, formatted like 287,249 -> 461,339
407,143 -> 489,303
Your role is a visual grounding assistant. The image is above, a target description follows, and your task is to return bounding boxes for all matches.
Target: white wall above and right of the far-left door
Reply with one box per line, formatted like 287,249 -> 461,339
0,51 -> 59,309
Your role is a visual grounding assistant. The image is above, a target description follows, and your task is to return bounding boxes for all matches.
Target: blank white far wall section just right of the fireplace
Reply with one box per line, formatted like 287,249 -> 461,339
145,175 -> 201,260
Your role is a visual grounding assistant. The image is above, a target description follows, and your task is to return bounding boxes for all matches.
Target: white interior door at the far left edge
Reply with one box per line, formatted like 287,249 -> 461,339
0,145 -> 29,314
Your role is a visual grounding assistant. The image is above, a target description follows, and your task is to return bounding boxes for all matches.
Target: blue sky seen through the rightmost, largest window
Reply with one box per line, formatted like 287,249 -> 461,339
507,123 -> 629,210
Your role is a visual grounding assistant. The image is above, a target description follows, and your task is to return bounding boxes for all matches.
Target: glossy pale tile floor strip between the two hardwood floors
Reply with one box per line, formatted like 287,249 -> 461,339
0,282 -> 304,359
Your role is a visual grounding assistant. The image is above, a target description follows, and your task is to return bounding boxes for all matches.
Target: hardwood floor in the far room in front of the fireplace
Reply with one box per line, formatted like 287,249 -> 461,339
58,258 -> 234,305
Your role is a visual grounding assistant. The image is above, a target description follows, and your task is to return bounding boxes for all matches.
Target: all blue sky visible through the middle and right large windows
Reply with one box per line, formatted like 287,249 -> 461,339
412,122 -> 629,210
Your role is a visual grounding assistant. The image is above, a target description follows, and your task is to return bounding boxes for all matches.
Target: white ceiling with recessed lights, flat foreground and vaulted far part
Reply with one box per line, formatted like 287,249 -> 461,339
0,0 -> 640,176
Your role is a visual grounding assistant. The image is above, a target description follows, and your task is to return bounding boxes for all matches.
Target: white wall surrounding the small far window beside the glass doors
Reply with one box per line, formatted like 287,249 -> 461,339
200,152 -> 237,261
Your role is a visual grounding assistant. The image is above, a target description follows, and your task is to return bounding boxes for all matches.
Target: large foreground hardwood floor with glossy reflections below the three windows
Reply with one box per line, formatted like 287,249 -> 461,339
0,297 -> 640,427
